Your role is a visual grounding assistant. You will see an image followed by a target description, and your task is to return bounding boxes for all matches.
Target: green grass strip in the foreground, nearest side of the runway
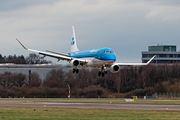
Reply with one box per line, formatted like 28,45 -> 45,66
0,107 -> 180,120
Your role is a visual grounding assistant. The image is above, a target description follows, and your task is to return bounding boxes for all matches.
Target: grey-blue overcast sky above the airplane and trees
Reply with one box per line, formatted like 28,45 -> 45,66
0,0 -> 180,64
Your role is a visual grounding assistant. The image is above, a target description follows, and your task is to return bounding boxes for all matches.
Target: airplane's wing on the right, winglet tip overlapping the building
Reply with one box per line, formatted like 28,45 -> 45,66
116,55 -> 156,66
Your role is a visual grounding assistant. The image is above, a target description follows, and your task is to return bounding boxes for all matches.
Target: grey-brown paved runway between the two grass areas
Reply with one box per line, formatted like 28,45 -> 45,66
0,100 -> 180,111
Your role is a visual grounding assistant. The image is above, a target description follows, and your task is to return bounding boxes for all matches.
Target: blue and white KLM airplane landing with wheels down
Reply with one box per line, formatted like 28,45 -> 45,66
16,26 -> 155,77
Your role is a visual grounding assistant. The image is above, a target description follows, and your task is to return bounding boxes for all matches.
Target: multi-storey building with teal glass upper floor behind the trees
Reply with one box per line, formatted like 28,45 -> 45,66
142,45 -> 180,63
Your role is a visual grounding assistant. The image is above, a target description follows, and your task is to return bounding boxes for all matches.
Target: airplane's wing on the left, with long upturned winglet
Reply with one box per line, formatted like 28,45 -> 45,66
16,38 -> 87,63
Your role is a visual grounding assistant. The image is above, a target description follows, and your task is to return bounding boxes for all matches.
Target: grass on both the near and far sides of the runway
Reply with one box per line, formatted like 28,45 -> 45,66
0,98 -> 180,120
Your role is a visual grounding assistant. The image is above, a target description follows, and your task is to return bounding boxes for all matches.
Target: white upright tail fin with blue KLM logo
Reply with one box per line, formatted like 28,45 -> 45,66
71,26 -> 79,52
